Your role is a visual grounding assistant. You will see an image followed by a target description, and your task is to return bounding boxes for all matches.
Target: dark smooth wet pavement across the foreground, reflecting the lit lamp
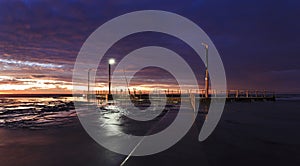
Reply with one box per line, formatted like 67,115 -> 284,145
0,97 -> 300,166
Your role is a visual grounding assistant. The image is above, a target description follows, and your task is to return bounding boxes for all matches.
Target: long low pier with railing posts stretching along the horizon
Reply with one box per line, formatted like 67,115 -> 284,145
86,89 -> 276,102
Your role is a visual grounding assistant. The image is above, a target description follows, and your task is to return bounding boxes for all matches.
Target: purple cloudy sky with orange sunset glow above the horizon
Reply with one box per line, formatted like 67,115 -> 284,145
0,0 -> 300,93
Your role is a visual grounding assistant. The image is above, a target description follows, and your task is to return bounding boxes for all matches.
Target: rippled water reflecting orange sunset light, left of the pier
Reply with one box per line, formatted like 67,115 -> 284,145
0,97 -> 76,129
